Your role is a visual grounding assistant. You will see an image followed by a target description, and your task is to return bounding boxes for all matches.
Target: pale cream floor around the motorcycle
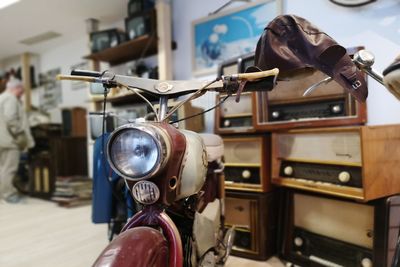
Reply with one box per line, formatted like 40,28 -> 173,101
0,198 -> 283,267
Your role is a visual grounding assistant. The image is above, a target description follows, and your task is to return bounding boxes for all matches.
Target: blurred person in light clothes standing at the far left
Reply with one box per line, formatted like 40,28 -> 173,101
0,76 -> 35,203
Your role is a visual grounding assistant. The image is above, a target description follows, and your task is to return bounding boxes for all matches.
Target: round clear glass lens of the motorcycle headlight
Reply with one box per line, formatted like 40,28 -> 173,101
109,128 -> 160,178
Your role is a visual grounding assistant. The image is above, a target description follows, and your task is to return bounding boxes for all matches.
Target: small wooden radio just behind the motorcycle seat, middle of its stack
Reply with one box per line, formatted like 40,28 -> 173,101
223,135 -> 271,192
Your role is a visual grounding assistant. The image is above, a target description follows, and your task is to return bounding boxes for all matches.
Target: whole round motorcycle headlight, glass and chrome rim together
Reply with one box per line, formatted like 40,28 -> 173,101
107,124 -> 169,181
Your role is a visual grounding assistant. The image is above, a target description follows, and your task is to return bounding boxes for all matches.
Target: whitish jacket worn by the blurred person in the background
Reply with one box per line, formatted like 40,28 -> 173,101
0,90 -> 34,149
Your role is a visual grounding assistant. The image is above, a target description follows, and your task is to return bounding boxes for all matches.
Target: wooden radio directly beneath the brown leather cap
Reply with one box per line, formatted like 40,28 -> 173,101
254,48 -> 367,130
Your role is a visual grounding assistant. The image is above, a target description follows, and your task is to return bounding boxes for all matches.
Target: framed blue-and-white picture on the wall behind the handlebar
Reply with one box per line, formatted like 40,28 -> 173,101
192,0 -> 283,76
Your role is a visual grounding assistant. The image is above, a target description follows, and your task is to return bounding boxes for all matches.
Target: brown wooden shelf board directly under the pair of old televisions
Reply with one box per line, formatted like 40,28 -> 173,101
84,35 -> 176,66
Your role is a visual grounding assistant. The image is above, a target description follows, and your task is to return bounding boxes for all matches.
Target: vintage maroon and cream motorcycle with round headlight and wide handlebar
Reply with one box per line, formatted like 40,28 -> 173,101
58,68 -> 279,267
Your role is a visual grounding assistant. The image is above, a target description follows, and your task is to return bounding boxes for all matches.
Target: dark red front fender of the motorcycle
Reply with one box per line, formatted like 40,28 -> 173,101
93,226 -> 169,267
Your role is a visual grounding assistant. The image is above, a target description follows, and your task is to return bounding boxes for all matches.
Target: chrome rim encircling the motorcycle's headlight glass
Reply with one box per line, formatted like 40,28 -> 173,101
107,123 -> 170,181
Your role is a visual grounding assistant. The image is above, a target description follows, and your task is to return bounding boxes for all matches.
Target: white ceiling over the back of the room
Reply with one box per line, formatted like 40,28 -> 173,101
0,0 -> 128,60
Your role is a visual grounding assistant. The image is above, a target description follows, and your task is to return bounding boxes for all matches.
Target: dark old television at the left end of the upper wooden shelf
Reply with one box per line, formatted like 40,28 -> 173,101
90,29 -> 126,53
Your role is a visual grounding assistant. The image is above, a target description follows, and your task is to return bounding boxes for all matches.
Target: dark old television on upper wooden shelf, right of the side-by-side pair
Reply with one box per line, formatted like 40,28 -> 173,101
125,9 -> 156,40
